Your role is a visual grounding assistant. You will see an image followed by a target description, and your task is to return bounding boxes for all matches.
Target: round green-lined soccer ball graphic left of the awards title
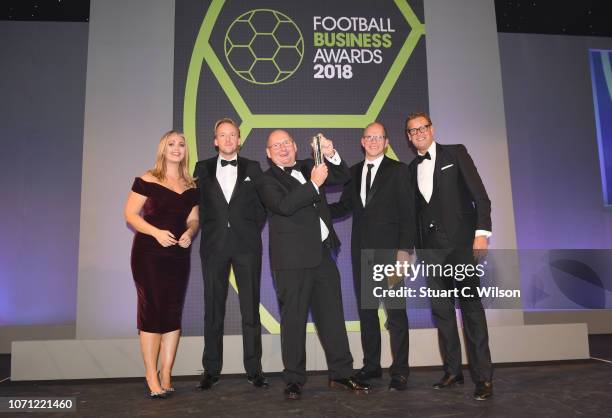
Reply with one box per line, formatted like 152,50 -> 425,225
224,9 -> 304,84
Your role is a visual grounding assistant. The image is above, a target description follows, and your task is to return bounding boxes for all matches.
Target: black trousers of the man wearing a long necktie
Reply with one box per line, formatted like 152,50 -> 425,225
353,250 -> 410,377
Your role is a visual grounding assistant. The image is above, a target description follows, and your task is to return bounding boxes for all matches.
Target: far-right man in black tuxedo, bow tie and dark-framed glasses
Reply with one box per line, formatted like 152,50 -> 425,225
406,113 -> 493,400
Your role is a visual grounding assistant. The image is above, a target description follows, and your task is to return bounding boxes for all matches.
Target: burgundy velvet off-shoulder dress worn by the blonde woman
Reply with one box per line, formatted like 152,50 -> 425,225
131,177 -> 198,333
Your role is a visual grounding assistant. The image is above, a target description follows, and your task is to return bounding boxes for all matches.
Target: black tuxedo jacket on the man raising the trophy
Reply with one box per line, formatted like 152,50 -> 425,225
260,159 -> 350,270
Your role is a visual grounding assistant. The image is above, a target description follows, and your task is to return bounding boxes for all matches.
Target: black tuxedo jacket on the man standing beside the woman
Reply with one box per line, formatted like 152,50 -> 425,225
194,156 -> 266,255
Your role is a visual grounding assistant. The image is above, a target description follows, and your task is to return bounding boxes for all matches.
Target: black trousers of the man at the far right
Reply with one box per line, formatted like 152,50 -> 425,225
419,232 -> 493,383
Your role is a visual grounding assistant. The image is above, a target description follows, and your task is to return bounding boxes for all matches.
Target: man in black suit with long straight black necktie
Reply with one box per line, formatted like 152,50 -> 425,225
330,122 -> 414,390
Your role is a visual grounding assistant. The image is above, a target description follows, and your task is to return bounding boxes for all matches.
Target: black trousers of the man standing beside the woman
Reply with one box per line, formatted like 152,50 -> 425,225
202,235 -> 261,376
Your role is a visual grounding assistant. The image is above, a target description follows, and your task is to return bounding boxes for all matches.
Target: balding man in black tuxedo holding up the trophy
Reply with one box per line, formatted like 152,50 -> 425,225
260,129 -> 369,399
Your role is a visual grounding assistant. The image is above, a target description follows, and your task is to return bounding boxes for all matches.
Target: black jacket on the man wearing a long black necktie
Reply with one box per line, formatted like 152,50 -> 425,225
330,157 -> 415,264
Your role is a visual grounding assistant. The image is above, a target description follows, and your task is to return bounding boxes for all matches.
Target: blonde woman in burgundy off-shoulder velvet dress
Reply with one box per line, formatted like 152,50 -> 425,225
125,131 -> 198,398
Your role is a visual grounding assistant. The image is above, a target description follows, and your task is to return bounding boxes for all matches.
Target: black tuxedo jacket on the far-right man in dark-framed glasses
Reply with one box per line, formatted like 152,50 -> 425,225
409,143 -> 491,247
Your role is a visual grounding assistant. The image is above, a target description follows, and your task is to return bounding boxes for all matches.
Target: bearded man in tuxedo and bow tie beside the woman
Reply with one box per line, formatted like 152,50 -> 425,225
194,118 -> 268,390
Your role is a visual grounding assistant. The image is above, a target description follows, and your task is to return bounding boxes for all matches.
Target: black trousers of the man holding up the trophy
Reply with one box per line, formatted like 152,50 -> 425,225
273,245 -> 353,384
